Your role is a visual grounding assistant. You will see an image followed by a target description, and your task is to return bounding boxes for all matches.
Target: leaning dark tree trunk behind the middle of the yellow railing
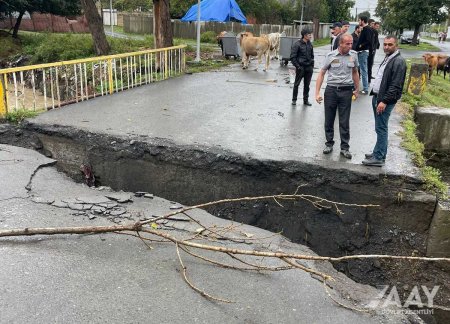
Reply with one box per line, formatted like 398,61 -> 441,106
81,0 -> 110,55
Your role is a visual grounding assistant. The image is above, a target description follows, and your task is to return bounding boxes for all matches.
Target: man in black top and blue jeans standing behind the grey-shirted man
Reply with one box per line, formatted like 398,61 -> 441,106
356,16 -> 373,94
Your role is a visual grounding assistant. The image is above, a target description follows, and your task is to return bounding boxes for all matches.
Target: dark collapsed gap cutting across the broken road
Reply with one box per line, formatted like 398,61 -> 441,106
0,123 -> 450,323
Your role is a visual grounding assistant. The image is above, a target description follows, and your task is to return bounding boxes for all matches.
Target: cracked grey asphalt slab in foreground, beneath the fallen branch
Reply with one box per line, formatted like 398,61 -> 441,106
0,145 -> 418,324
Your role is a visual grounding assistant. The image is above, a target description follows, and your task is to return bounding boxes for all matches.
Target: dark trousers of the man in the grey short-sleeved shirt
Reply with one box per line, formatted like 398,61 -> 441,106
324,86 -> 353,150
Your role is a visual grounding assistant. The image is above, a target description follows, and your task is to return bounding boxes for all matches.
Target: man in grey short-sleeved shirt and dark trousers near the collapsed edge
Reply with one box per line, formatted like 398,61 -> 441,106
316,34 -> 359,159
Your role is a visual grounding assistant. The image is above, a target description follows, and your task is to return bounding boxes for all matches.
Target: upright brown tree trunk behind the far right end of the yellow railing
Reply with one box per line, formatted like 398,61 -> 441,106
153,0 -> 173,48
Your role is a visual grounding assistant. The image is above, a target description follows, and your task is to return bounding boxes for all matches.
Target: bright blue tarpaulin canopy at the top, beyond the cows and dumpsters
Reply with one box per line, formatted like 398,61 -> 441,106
181,0 -> 247,24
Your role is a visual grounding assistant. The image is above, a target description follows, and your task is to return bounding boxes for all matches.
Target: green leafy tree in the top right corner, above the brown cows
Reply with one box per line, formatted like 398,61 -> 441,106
376,0 -> 450,45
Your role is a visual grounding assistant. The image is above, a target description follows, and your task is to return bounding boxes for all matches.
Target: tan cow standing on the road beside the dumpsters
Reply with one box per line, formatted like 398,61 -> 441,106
240,32 -> 270,71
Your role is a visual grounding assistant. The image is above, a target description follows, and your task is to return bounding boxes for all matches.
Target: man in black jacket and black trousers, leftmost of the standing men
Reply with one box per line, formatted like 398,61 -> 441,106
291,28 -> 314,106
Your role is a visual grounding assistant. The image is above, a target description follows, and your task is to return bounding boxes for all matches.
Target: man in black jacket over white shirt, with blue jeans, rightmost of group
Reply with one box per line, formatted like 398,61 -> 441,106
362,36 -> 406,167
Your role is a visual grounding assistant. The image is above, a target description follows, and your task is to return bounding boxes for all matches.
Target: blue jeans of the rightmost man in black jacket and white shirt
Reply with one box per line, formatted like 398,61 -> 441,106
372,95 -> 395,160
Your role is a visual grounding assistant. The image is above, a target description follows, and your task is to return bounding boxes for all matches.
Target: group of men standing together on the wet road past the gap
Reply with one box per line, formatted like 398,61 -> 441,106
290,16 -> 406,166
